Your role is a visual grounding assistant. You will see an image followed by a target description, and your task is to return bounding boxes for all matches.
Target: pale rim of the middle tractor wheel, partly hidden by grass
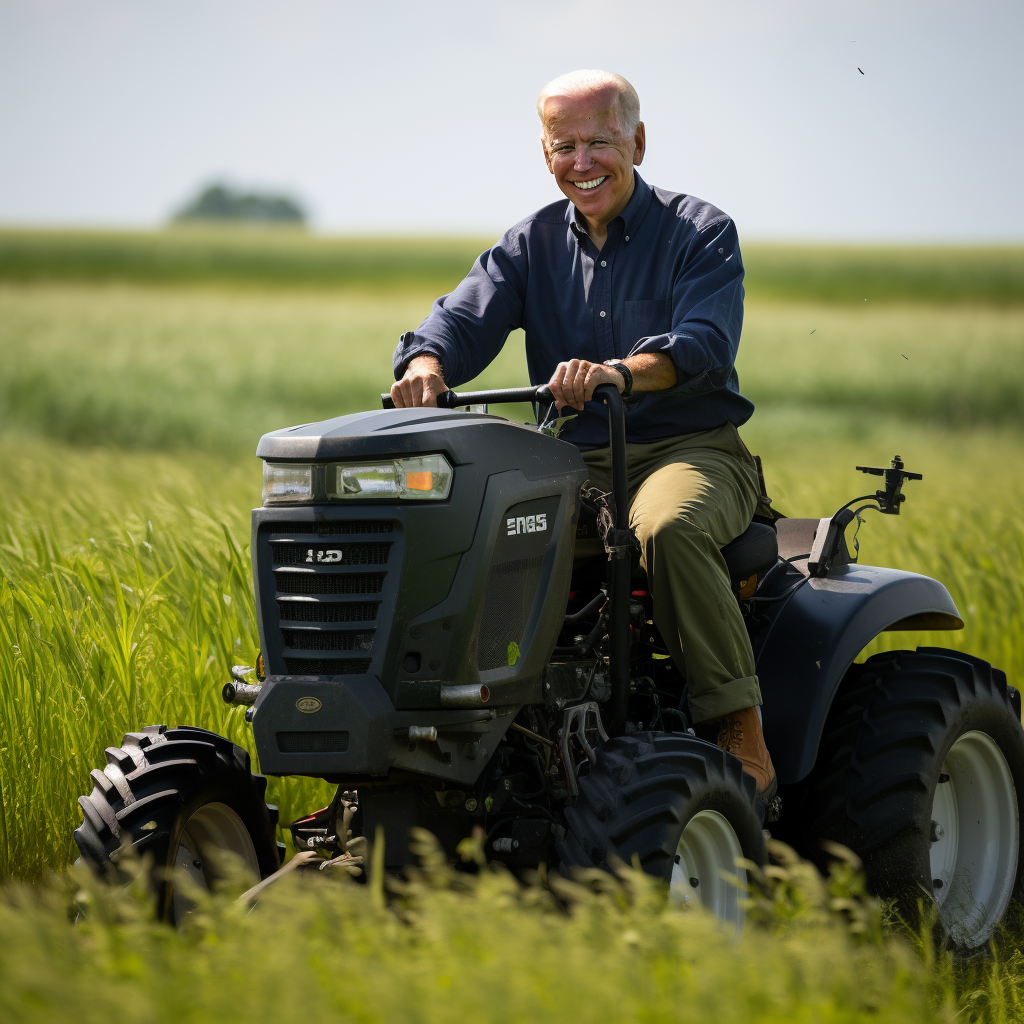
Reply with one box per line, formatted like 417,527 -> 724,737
669,811 -> 746,931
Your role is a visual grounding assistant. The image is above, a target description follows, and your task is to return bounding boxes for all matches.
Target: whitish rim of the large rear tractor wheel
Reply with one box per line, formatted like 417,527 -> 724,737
929,731 -> 1020,947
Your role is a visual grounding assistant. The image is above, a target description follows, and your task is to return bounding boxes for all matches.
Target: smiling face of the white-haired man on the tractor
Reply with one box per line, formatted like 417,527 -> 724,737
542,87 -> 645,224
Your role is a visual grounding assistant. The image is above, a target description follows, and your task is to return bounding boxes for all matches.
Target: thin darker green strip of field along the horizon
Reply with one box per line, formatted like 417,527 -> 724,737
0,226 -> 1024,305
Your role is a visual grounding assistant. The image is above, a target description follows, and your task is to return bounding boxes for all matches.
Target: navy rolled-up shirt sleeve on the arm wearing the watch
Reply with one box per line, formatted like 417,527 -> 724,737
630,217 -> 743,395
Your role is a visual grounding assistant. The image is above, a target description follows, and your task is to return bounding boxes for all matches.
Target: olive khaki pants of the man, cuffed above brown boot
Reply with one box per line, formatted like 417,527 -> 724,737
583,423 -> 761,722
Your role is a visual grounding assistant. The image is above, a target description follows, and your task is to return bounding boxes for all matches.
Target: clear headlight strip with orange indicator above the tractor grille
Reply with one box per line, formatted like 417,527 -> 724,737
263,455 -> 452,505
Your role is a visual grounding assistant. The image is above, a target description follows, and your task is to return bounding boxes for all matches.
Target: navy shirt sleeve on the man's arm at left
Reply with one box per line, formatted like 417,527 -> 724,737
392,226 -> 526,387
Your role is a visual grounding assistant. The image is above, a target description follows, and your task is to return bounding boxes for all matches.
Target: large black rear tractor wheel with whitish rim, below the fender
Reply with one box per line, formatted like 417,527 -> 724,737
783,647 -> 1024,954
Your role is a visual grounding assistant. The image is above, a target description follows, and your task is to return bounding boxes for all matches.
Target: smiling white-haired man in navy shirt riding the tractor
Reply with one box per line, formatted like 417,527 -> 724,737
391,71 -> 776,801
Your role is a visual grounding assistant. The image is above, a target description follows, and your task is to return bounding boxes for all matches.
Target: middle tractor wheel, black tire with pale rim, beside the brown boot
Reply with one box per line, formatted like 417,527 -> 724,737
555,732 -> 767,929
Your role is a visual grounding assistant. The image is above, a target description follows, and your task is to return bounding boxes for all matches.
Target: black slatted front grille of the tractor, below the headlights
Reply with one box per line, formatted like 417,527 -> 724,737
257,519 -> 401,679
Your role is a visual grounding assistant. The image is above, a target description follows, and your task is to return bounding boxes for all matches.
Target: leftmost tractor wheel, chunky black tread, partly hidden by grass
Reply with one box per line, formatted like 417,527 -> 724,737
75,725 -> 281,924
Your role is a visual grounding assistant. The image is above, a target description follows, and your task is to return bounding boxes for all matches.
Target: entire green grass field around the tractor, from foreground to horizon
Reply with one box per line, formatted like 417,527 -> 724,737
0,229 -> 1024,1021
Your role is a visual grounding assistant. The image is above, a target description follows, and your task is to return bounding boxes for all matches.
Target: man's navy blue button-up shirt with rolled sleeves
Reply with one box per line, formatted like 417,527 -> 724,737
394,174 -> 754,450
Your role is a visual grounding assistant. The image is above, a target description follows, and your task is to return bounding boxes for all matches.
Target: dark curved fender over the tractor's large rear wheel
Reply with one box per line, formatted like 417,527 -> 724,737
757,565 -> 964,784
